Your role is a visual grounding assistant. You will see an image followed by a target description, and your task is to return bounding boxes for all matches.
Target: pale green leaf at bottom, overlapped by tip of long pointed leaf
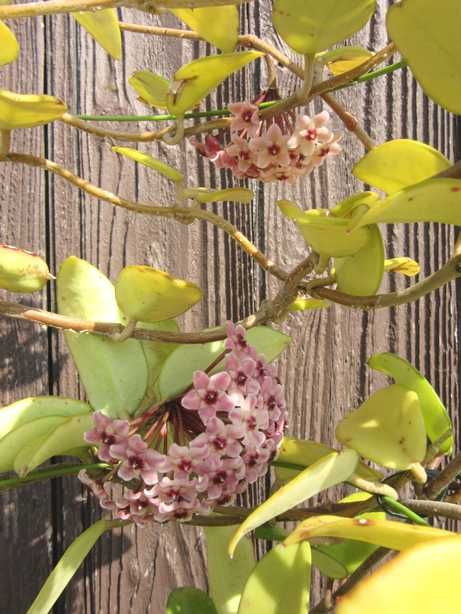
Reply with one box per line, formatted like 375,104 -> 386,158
204,527 -> 256,614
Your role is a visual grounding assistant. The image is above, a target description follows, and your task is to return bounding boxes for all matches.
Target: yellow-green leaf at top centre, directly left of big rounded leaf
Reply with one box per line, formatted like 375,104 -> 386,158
171,6 -> 239,52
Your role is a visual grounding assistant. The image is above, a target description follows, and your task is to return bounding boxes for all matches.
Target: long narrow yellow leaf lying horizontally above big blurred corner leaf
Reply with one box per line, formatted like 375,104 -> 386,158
284,516 -> 453,550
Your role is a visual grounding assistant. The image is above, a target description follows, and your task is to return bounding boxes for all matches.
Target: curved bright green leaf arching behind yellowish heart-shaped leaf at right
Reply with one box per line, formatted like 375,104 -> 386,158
368,352 -> 454,454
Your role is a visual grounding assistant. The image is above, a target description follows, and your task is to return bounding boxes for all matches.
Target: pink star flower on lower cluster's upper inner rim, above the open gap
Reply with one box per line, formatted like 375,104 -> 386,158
181,371 -> 234,423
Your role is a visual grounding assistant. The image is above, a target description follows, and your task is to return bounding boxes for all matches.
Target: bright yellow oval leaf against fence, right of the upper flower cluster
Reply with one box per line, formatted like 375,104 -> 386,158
352,139 -> 450,194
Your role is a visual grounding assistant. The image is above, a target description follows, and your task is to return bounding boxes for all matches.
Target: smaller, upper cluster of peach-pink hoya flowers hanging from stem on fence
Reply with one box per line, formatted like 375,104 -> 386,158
193,102 -> 341,183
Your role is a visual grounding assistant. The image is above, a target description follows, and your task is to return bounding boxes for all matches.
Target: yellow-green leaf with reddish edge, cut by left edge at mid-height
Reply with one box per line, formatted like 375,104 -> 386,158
0,245 -> 53,293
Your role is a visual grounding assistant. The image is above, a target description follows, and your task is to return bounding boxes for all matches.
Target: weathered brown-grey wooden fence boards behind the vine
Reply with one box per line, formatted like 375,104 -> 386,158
0,0 -> 460,614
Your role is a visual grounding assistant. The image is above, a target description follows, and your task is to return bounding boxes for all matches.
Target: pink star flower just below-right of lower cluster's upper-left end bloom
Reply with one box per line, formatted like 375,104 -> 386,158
111,435 -> 165,484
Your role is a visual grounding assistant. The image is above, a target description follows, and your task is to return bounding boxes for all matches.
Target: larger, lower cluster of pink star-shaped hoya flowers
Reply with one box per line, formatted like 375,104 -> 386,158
79,324 -> 286,525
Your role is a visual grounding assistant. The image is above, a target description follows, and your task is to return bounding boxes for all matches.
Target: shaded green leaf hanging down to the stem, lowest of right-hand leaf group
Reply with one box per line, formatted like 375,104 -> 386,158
335,225 -> 384,296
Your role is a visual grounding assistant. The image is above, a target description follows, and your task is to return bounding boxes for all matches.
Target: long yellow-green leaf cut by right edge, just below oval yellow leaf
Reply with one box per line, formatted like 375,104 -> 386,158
350,179 -> 461,230
